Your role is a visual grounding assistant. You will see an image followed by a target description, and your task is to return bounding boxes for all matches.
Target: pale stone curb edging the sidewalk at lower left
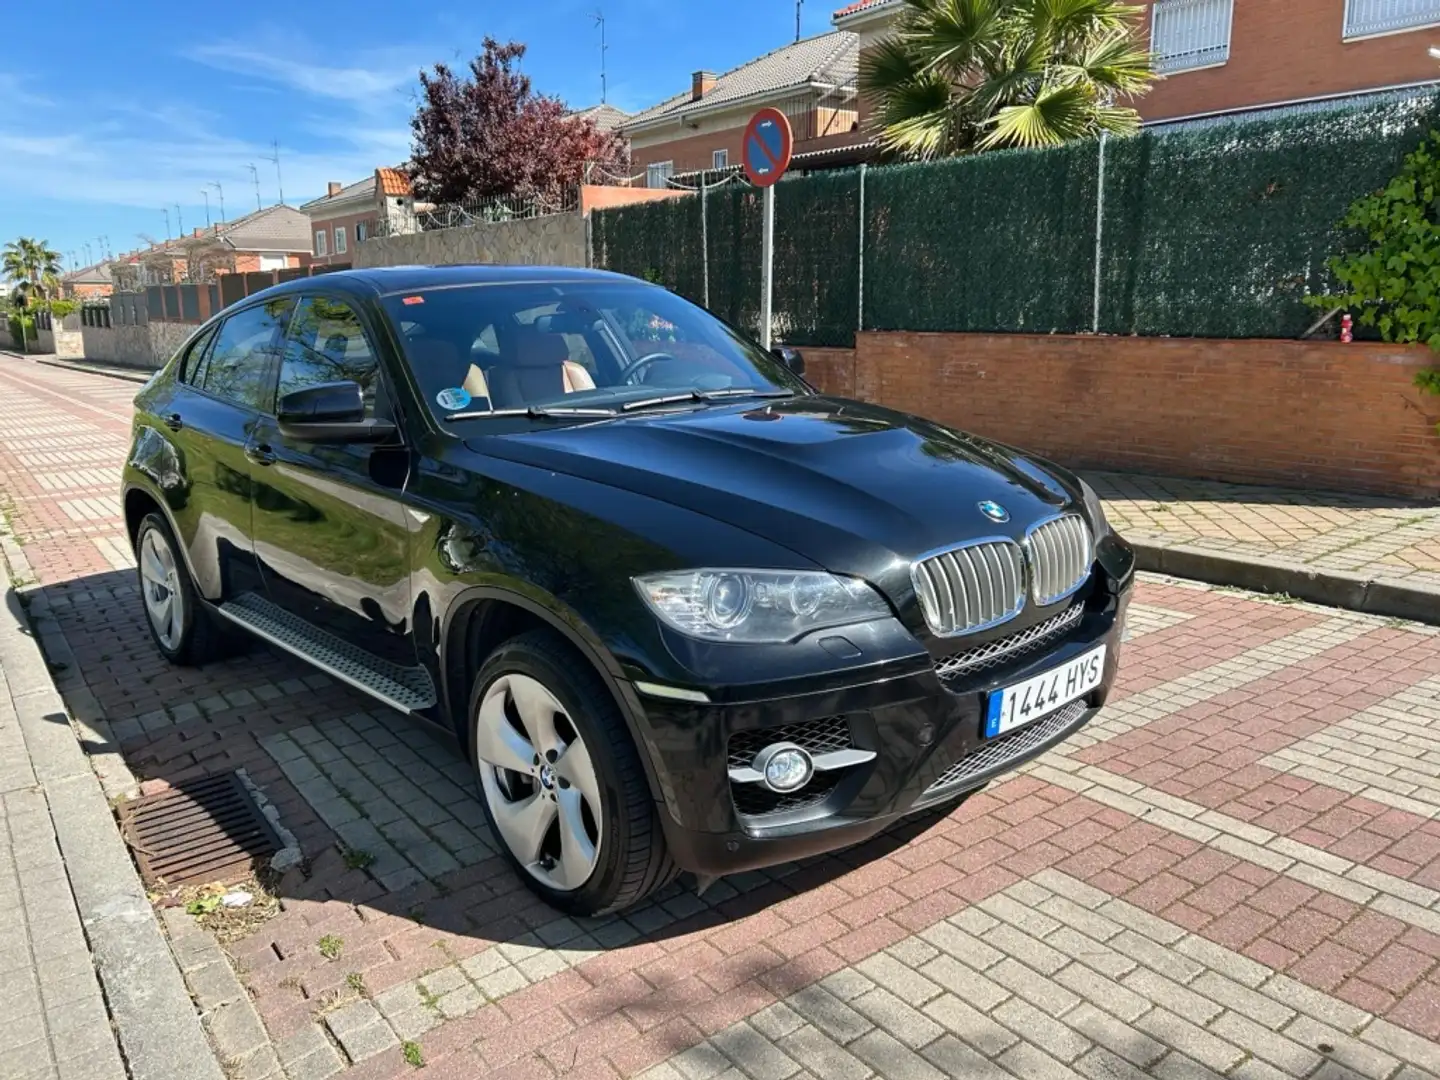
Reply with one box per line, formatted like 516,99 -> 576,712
0,537 -> 223,1080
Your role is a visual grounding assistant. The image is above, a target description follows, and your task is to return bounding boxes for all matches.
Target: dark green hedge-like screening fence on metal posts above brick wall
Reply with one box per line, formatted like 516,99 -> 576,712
592,96 -> 1440,346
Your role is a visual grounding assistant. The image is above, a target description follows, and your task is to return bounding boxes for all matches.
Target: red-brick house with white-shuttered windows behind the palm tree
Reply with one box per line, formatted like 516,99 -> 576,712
831,0 -> 1440,121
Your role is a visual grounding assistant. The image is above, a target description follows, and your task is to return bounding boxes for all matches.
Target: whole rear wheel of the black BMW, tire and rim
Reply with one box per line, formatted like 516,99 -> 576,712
135,513 -> 228,667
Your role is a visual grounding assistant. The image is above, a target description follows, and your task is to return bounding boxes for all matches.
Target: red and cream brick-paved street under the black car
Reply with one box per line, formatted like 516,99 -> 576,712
0,351 -> 1440,1080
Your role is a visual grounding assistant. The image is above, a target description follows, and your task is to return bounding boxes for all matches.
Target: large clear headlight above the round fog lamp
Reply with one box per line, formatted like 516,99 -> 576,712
635,570 -> 890,645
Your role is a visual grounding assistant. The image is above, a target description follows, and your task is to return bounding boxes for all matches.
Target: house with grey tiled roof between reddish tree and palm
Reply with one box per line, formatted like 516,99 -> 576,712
619,30 -> 865,187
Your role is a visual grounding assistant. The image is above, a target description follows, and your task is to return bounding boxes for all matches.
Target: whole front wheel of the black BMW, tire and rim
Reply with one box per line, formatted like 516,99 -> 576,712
468,631 -> 678,916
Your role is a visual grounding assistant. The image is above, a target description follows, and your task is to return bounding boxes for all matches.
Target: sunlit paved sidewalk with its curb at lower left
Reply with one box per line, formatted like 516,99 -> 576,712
0,538 -> 220,1080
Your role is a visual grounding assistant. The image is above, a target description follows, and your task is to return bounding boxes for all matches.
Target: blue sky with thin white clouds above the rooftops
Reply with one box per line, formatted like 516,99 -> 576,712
0,0 -> 842,272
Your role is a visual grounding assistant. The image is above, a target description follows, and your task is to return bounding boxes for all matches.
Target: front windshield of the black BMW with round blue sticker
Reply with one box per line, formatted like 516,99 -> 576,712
383,281 -> 808,420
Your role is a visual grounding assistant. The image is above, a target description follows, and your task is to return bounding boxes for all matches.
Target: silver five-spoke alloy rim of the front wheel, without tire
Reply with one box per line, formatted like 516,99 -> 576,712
475,674 -> 602,893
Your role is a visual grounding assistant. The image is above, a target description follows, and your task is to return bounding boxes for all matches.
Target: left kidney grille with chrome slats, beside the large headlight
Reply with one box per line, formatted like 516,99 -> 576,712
910,540 -> 1025,638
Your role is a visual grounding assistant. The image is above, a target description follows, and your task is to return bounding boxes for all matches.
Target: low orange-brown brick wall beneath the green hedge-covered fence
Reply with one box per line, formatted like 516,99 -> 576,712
804,333 -> 1440,498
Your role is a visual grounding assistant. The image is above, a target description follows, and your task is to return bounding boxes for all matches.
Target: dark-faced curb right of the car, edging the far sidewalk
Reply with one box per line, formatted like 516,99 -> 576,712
1130,540 -> 1440,626
